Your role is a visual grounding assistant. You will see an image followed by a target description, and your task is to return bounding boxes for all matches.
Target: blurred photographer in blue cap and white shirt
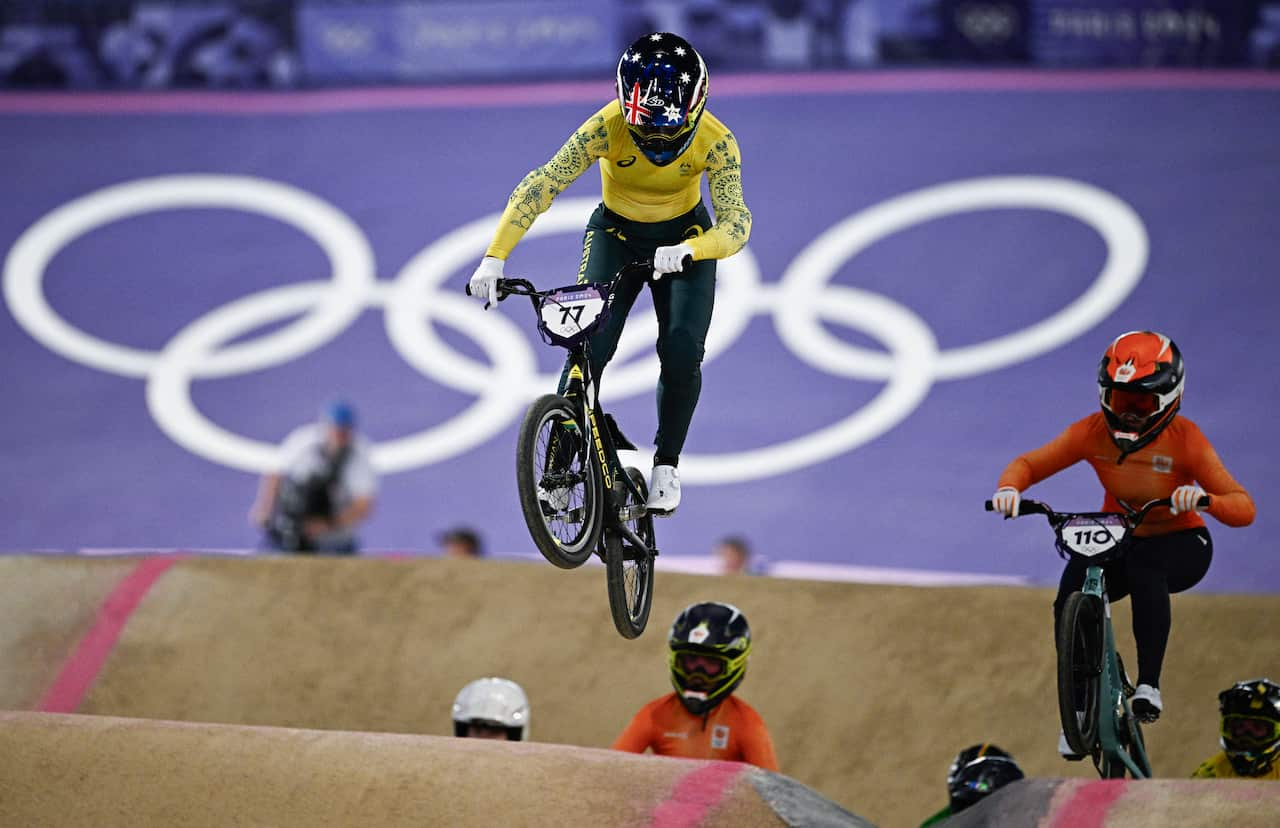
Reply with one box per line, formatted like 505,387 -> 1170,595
250,401 -> 378,554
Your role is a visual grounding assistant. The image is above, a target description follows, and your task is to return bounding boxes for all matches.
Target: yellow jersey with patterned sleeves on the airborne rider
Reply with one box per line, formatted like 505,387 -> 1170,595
485,100 -> 751,260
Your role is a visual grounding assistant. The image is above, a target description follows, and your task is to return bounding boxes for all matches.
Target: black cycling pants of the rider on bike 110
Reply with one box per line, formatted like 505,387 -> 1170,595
1053,527 -> 1213,687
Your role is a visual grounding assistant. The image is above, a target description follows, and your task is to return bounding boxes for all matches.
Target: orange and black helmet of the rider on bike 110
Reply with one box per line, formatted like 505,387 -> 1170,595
1098,330 -> 1185,462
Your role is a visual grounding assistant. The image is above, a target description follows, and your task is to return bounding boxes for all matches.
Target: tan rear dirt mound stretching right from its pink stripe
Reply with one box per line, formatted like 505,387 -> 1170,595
0,558 -> 1280,825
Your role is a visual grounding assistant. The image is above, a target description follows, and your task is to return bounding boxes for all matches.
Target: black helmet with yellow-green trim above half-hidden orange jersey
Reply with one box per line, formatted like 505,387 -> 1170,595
667,601 -> 751,715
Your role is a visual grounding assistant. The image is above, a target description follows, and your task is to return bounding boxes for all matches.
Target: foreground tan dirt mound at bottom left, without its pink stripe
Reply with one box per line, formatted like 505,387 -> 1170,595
0,713 -> 783,828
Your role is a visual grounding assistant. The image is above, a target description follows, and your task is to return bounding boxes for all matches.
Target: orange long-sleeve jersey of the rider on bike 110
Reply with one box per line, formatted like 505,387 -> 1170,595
998,411 -> 1253,536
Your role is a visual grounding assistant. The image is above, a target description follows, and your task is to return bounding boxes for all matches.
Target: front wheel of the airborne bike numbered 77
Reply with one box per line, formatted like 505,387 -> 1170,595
516,394 -> 604,569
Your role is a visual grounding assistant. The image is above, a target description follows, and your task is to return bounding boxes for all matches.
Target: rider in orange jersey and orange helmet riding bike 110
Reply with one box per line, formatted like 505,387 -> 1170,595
992,330 -> 1253,737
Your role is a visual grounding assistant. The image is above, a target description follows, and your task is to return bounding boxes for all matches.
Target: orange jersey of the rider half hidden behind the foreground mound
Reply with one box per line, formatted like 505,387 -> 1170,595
613,692 -> 778,770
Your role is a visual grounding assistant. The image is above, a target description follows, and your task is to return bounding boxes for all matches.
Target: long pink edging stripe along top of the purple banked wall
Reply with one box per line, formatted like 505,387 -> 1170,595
0,69 -> 1280,115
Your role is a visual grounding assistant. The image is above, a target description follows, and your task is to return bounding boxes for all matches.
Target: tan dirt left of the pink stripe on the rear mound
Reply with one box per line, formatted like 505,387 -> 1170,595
0,555 -> 137,710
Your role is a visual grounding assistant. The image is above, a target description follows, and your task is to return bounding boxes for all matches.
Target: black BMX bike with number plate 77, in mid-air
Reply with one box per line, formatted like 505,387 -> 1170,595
468,262 -> 658,639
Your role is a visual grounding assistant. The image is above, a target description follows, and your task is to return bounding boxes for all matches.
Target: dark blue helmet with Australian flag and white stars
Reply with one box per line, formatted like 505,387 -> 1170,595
618,32 -> 707,166
